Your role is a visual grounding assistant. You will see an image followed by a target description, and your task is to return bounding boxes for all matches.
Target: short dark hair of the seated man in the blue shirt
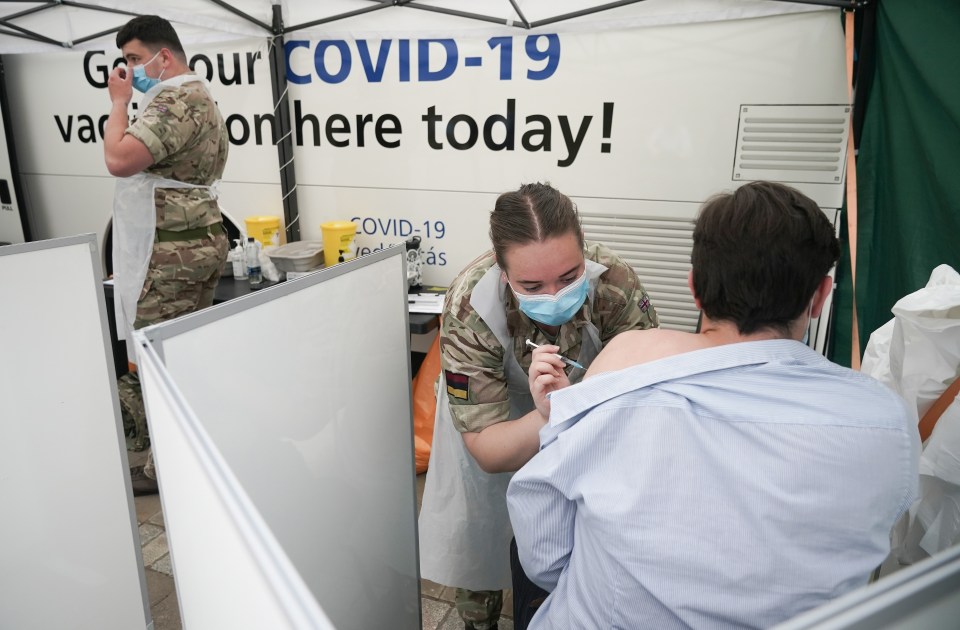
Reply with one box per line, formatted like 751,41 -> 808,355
690,182 -> 840,334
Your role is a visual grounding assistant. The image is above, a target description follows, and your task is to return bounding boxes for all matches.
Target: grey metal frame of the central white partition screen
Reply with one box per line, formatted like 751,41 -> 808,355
142,244 -> 422,628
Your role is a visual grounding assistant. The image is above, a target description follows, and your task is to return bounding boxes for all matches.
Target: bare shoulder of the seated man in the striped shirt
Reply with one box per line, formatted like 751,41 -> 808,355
585,328 -> 704,378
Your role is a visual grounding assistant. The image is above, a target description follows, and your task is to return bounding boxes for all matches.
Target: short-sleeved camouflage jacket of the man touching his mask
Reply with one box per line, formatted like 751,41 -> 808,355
126,81 -> 229,231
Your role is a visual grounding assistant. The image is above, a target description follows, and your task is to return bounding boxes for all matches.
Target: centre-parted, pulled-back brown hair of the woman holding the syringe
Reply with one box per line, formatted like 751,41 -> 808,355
490,183 -> 583,270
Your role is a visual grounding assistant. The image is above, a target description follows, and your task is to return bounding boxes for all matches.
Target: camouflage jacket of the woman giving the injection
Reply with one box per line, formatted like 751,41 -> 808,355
440,242 -> 659,432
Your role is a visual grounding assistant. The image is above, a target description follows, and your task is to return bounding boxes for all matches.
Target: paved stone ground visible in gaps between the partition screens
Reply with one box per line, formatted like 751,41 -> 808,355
133,452 -> 513,630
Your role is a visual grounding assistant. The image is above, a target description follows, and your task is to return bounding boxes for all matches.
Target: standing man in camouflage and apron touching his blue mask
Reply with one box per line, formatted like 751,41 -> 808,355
104,16 -> 229,494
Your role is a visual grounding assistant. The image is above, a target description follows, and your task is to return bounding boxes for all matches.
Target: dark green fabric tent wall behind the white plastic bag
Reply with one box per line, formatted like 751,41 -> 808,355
830,0 -> 960,365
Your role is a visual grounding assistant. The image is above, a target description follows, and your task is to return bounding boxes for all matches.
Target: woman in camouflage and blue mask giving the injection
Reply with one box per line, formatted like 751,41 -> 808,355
420,184 -> 658,630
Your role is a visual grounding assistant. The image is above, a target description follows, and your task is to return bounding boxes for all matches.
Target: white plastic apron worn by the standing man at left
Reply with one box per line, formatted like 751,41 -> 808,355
113,74 -> 217,361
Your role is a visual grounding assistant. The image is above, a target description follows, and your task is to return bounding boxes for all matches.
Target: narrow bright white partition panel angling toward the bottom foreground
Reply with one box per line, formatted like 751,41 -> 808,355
137,344 -> 333,630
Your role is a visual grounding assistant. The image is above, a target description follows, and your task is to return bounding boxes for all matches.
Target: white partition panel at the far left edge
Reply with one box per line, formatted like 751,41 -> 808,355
0,235 -> 153,630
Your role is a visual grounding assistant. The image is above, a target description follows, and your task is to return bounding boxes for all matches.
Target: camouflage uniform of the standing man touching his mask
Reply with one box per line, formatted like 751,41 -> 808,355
119,76 -> 229,477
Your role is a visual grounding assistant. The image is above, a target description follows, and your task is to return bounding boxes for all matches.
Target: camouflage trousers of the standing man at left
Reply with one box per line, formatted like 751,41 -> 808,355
117,234 -> 229,478
